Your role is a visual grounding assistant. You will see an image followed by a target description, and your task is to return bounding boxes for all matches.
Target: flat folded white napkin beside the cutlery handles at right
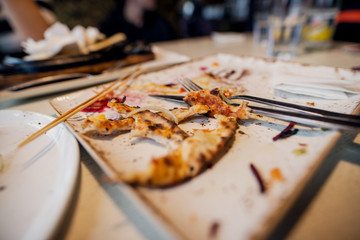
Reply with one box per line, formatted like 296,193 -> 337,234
272,64 -> 360,100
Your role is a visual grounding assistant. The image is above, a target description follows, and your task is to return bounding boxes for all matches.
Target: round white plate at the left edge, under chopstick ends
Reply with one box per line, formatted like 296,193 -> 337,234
0,110 -> 79,239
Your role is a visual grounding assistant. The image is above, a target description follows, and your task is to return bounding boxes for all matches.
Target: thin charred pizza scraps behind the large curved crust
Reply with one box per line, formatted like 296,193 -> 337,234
83,99 -> 209,147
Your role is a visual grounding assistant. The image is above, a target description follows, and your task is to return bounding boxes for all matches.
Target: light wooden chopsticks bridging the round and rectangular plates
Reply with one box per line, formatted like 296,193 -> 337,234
17,68 -> 146,149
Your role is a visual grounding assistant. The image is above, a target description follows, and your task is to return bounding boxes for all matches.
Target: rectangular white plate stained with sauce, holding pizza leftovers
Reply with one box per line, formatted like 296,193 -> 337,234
51,54 -> 360,239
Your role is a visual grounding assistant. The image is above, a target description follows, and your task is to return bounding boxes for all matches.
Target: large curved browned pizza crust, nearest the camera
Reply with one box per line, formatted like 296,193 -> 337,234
119,114 -> 237,187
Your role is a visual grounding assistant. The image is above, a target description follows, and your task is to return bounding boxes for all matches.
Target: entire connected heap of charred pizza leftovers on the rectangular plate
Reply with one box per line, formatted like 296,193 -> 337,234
84,89 -> 249,187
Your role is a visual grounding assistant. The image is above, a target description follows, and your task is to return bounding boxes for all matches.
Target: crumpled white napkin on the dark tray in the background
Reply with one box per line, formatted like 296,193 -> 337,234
22,22 -> 105,60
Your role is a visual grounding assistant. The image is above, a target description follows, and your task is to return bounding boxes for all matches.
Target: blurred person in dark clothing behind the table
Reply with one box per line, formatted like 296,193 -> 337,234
100,0 -> 177,43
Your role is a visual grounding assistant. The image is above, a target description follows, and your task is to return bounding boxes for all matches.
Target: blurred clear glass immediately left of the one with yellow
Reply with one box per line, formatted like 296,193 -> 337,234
267,0 -> 308,59
